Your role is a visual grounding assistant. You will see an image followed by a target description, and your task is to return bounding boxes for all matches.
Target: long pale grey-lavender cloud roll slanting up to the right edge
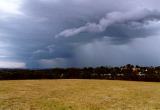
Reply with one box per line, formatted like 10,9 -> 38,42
55,10 -> 160,38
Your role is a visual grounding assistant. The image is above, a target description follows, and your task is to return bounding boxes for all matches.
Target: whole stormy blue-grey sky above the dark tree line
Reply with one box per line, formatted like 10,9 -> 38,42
0,0 -> 160,68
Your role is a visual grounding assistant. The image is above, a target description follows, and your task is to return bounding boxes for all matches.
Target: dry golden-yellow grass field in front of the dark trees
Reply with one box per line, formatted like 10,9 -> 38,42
0,80 -> 160,110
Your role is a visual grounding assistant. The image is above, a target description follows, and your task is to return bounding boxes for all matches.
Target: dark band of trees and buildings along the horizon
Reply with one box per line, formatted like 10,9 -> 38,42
0,64 -> 160,82
